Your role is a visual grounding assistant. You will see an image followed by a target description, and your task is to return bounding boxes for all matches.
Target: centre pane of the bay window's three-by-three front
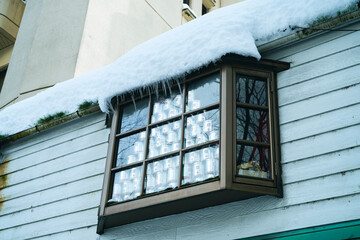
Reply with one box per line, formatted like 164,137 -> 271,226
149,120 -> 181,158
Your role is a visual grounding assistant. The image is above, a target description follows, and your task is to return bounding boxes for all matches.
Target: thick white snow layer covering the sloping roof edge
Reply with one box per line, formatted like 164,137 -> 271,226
0,0 -> 358,134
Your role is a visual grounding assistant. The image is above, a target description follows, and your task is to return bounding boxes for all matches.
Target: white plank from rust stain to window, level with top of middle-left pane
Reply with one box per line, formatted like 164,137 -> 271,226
7,143 -> 108,187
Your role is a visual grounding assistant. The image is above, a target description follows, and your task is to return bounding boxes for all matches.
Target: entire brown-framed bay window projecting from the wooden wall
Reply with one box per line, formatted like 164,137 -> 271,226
98,56 -> 288,233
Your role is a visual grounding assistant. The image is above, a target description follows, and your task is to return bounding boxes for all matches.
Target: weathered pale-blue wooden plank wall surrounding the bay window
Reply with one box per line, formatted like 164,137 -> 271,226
0,20 -> 360,240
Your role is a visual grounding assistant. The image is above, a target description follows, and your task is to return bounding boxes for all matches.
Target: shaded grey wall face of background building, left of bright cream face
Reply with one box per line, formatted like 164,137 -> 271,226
0,0 -> 88,107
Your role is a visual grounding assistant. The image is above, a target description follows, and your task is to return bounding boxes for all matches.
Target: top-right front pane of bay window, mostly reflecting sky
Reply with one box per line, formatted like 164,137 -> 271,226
186,73 -> 220,111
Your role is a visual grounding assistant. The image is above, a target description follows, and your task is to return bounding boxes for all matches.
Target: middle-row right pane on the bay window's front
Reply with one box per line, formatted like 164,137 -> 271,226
184,109 -> 220,147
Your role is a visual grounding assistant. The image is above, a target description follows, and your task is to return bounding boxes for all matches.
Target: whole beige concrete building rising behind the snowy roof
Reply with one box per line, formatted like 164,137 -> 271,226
0,0 -> 245,109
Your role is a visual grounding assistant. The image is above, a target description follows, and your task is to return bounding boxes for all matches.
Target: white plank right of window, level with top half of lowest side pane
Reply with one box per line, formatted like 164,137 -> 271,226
281,125 -> 360,163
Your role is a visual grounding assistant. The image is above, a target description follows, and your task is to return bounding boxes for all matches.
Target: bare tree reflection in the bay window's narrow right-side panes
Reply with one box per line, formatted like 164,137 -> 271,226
236,77 -> 269,171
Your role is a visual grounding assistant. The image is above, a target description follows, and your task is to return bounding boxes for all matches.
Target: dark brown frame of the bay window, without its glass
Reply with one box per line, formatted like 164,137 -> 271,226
97,54 -> 290,234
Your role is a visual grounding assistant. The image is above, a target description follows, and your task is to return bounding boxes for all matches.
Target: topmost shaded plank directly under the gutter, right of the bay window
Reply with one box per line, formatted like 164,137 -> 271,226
261,23 -> 360,60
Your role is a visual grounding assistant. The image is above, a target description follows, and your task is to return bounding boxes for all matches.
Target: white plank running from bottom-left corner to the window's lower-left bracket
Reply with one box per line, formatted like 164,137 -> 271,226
0,208 -> 98,240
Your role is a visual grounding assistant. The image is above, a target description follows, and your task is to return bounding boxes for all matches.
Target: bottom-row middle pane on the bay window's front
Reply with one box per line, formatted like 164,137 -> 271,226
145,155 -> 179,193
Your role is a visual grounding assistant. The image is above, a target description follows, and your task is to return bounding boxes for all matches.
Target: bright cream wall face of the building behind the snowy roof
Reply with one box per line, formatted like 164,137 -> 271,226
75,0 -> 182,76
